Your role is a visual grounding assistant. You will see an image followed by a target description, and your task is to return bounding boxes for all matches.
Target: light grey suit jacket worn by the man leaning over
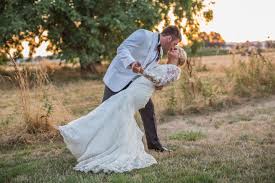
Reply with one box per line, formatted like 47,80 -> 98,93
103,29 -> 159,92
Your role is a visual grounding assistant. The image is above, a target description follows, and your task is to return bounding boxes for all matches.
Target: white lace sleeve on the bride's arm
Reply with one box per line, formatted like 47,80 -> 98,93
143,65 -> 180,86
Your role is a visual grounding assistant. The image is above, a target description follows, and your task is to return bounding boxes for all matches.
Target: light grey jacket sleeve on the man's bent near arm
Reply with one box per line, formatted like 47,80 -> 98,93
117,29 -> 146,69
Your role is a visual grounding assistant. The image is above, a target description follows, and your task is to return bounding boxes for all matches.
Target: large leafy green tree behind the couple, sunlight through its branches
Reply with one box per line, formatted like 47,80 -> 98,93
0,0 -> 216,71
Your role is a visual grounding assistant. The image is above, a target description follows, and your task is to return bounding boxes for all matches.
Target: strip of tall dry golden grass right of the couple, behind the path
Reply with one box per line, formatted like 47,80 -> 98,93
154,52 -> 275,119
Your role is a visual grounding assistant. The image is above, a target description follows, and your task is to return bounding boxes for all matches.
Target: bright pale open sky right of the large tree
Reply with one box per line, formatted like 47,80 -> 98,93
201,0 -> 275,42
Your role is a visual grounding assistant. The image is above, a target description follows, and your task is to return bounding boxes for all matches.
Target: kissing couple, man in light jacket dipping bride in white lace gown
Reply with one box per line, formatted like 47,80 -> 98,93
58,26 -> 187,173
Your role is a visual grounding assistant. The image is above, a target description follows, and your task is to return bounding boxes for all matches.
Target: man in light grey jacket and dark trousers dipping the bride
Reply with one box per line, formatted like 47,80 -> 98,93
102,26 -> 181,152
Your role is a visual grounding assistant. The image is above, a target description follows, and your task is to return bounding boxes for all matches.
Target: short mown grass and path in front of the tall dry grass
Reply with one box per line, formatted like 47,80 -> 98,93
0,95 -> 275,183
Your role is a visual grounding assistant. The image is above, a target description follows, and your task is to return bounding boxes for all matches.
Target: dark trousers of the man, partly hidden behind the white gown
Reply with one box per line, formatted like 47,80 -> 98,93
102,82 -> 161,149
